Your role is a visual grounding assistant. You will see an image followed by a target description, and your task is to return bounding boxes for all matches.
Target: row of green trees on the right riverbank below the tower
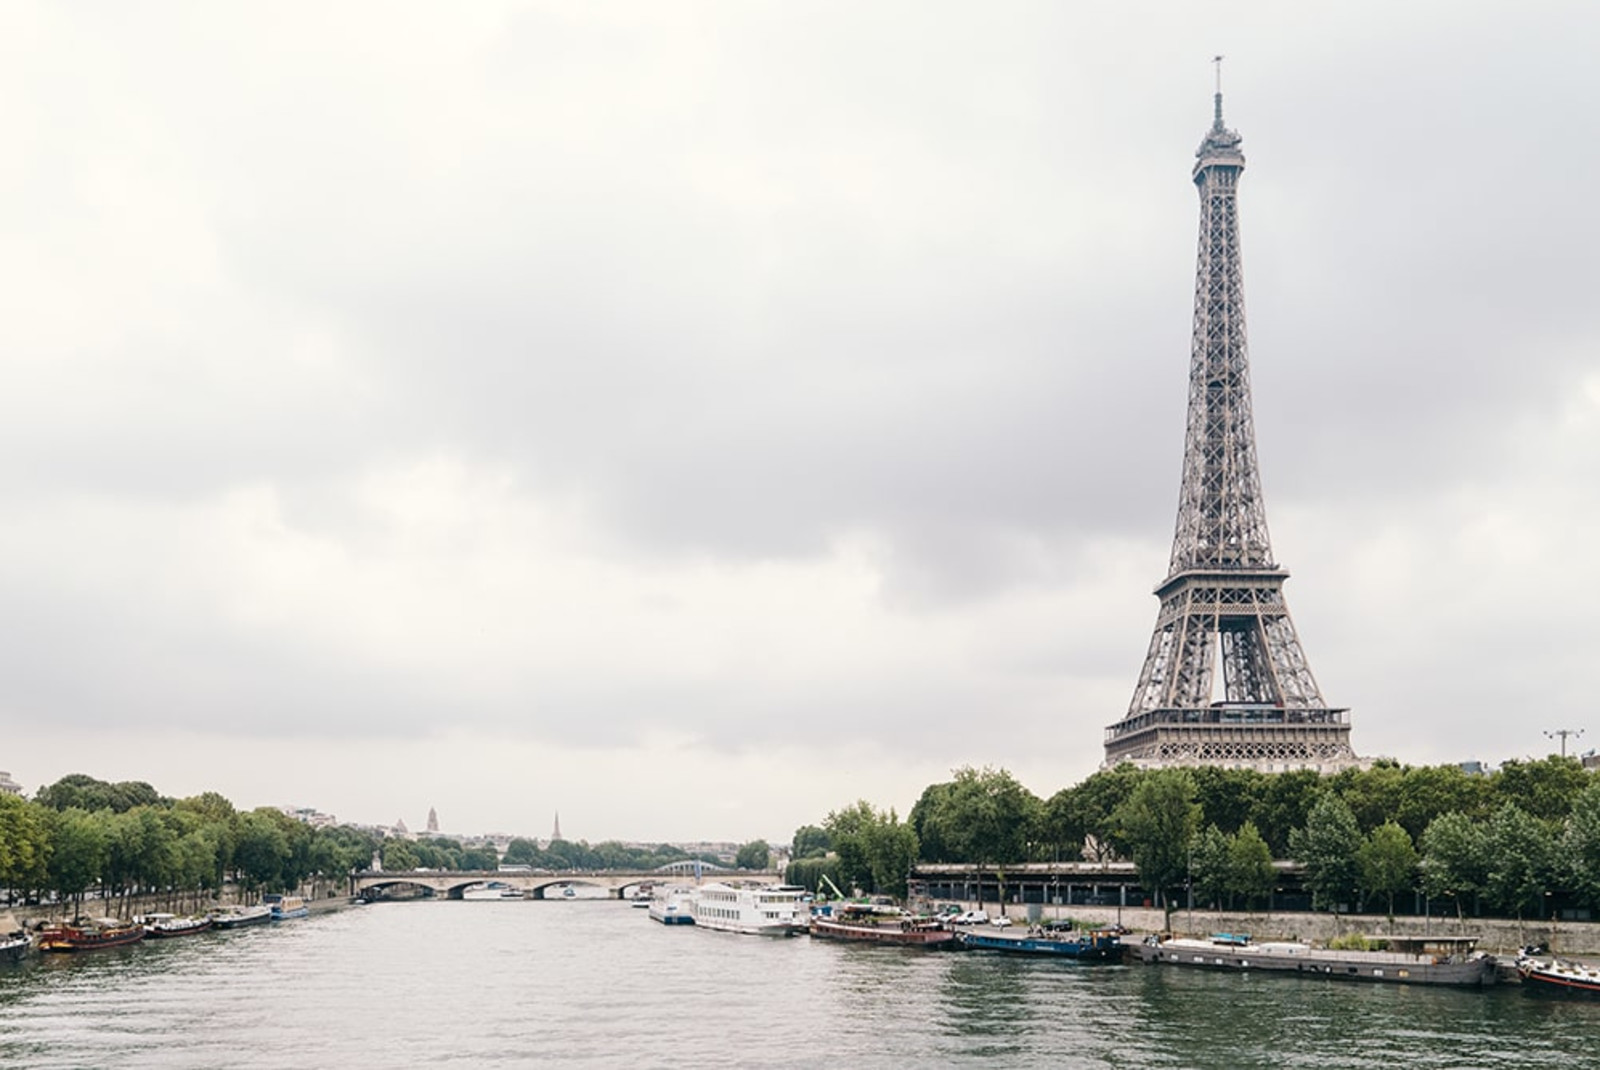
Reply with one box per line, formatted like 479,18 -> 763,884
787,755 -> 1600,921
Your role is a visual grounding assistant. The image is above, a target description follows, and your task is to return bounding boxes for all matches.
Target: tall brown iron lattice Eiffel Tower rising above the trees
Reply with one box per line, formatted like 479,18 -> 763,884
1106,86 -> 1360,773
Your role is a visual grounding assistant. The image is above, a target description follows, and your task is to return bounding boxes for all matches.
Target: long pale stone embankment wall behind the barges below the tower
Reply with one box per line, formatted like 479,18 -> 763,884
970,902 -> 1600,956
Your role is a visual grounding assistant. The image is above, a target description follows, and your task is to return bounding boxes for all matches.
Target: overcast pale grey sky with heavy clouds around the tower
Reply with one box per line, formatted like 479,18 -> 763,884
0,0 -> 1600,841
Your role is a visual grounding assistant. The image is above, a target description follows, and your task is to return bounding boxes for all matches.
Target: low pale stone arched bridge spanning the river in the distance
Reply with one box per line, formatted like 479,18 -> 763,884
350,862 -> 782,899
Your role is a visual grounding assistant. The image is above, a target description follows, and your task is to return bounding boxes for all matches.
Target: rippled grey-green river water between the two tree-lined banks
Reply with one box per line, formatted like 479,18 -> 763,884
0,900 -> 1600,1070
